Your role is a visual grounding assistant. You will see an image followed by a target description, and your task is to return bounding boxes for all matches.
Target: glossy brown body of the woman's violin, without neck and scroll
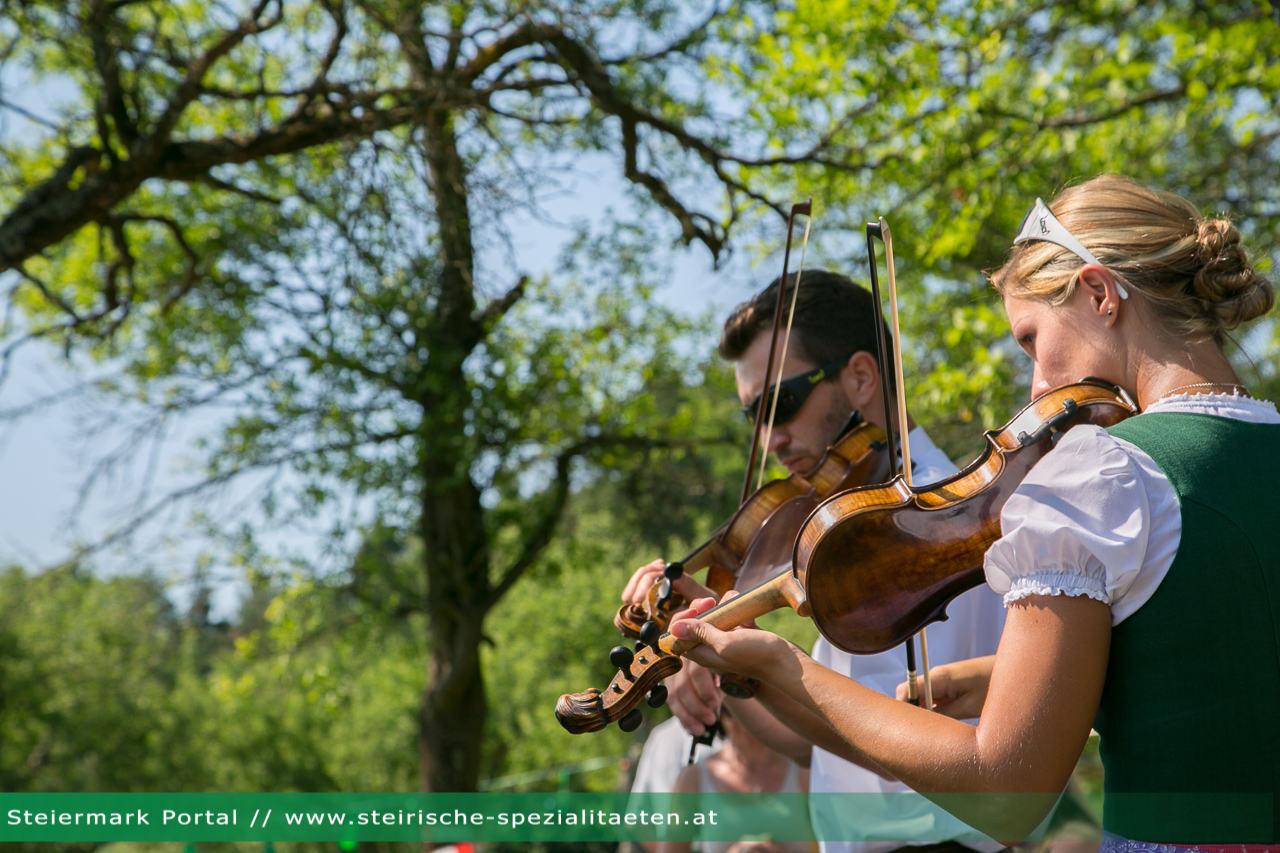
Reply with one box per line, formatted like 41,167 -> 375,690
795,380 -> 1137,654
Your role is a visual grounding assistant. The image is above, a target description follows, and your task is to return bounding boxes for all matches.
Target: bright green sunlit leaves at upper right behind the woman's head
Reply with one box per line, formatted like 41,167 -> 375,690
708,0 -> 1280,459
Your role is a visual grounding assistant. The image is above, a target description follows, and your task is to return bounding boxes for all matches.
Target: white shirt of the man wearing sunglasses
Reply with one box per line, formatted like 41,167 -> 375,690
809,427 -> 1005,853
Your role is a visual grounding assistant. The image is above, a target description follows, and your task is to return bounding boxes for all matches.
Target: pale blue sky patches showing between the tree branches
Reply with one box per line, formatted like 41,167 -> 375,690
0,61 -> 782,617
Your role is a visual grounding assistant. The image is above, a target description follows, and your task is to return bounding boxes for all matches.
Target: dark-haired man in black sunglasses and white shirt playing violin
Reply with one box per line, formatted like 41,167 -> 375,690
623,270 -> 1004,853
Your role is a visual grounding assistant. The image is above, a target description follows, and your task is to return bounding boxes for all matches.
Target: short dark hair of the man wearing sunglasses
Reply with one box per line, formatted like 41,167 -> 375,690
719,269 -> 892,365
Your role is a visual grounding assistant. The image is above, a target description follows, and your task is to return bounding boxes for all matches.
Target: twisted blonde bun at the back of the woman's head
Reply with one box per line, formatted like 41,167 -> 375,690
1193,218 -> 1275,329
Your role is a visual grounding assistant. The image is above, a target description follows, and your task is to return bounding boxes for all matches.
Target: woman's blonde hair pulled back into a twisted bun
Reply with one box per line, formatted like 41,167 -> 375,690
991,174 -> 1275,346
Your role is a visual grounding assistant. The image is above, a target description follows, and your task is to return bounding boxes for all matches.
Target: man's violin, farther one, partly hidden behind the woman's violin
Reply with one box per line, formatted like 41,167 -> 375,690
613,423 -> 888,638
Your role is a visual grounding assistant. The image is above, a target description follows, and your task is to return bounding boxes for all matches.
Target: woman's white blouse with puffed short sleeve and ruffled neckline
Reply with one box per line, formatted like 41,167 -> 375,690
984,393 -> 1280,625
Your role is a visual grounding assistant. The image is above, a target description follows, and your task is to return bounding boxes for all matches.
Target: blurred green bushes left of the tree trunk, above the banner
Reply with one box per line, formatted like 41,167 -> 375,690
0,558 -> 422,792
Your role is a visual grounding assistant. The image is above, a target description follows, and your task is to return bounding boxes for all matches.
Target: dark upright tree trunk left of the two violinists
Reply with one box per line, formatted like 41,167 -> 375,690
419,111 -> 490,792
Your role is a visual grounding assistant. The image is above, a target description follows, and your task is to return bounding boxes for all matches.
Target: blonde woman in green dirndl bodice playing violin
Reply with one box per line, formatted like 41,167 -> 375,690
672,175 -> 1280,853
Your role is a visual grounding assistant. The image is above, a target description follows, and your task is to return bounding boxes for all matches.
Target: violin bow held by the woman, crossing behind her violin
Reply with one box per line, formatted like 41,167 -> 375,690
867,216 -> 933,711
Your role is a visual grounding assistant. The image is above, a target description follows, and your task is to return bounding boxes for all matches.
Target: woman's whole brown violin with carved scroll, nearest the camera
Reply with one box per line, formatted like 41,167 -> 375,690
556,379 -> 1138,734
